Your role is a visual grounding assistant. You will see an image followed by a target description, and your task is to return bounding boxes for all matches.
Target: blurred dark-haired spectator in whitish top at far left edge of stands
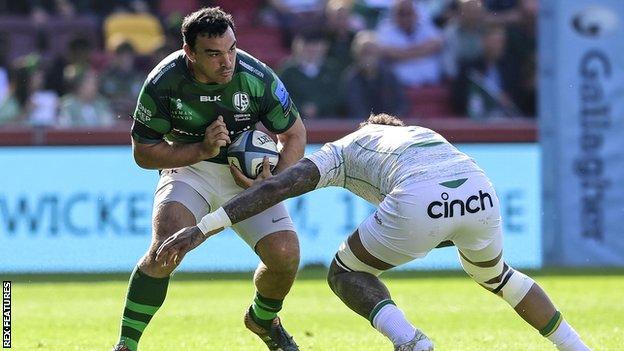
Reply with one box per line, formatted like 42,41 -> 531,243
0,54 -> 58,127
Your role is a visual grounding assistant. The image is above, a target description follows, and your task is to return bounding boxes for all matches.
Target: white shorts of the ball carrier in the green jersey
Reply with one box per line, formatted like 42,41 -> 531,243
154,161 -> 295,250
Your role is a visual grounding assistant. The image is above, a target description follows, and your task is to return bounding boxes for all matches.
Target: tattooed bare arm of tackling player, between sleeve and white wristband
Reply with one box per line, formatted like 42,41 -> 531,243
223,158 -> 321,223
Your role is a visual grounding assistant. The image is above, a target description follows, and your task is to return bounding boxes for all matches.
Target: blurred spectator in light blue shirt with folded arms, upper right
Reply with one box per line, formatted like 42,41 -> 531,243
377,0 -> 442,87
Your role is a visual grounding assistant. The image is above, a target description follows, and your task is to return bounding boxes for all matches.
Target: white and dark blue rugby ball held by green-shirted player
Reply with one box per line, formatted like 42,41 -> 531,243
227,130 -> 279,179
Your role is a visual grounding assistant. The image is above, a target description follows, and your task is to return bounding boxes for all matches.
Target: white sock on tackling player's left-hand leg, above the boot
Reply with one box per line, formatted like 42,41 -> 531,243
373,304 -> 416,346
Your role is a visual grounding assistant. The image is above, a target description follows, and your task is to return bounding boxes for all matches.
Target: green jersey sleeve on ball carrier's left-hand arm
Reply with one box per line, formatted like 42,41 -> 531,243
132,82 -> 171,144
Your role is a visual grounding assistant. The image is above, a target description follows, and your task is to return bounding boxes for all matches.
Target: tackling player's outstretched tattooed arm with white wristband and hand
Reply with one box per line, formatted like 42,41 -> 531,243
156,158 -> 320,263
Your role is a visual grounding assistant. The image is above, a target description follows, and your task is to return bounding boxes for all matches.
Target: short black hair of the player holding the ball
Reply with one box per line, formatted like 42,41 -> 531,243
182,7 -> 235,50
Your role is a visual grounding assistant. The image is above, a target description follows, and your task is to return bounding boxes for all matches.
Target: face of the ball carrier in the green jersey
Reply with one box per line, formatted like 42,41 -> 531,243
184,28 -> 236,84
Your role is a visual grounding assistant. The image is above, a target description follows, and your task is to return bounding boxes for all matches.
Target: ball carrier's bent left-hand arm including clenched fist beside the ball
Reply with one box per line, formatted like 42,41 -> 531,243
132,116 -> 230,169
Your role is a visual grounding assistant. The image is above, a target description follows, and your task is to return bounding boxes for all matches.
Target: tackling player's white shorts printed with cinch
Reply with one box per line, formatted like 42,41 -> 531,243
338,173 -> 502,266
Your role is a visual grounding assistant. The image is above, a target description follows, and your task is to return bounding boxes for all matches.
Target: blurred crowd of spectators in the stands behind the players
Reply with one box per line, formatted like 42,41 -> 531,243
0,0 -> 538,128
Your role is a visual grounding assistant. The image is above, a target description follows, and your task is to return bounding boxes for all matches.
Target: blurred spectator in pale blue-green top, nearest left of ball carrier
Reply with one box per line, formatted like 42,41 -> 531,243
58,70 -> 115,128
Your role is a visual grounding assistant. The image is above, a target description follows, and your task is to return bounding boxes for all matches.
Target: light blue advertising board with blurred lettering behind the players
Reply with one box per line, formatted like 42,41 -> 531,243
0,144 -> 542,272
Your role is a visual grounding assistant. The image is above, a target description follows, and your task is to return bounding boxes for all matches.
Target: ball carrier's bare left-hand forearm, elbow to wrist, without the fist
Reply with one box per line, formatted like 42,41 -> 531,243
133,141 -> 216,169
